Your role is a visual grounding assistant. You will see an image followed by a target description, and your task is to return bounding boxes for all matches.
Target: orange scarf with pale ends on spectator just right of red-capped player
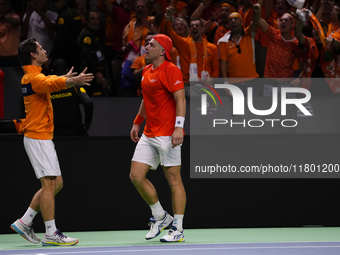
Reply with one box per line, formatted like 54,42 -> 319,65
189,35 -> 210,82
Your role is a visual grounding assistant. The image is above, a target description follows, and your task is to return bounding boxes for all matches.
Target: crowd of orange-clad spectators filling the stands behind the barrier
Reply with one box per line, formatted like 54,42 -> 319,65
0,0 -> 340,97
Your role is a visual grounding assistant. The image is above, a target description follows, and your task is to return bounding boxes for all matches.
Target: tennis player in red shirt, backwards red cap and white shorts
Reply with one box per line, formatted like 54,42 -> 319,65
130,34 -> 186,242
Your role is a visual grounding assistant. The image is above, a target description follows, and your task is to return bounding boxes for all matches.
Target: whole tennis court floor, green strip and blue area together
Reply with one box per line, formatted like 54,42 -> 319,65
0,227 -> 340,255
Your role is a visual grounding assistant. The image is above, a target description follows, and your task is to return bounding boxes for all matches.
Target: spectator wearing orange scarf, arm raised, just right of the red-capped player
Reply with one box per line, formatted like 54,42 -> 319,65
165,6 -> 219,87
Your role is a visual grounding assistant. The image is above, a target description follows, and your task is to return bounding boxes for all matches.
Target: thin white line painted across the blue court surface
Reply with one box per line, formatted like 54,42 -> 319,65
5,246 -> 340,255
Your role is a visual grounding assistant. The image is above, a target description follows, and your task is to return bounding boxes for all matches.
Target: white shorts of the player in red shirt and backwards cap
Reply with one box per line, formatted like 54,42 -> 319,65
132,134 -> 181,170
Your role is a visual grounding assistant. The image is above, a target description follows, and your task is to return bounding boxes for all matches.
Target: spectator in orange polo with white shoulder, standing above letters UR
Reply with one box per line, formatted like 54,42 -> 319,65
218,12 -> 260,96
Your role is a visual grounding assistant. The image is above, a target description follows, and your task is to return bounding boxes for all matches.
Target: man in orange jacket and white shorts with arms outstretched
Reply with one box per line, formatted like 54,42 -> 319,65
11,39 -> 93,246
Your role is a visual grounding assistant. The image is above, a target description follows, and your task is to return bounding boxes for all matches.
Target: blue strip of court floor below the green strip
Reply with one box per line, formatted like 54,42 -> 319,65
0,242 -> 340,255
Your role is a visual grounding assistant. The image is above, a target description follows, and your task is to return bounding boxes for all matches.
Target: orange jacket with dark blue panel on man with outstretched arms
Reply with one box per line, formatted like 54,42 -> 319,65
21,65 -> 67,140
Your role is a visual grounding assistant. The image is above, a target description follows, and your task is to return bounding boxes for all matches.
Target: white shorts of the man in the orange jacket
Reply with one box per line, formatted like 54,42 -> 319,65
24,136 -> 61,179
